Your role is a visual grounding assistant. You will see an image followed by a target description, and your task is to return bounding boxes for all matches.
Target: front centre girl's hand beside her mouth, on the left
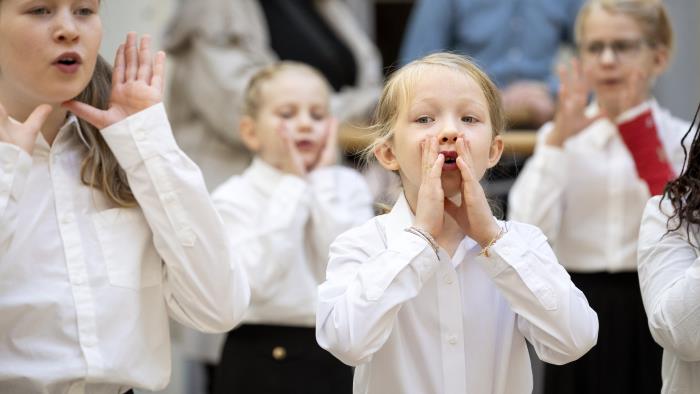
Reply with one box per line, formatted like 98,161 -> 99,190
415,136 -> 445,238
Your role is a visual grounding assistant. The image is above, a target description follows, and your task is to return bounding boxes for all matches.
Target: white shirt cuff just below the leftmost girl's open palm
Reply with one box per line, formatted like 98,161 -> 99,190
102,103 -> 179,170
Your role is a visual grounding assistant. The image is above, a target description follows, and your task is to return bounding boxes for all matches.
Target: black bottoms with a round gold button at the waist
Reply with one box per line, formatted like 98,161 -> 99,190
214,325 -> 353,394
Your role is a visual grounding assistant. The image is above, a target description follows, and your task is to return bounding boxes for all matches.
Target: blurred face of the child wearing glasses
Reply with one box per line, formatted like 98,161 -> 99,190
581,6 -> 668,106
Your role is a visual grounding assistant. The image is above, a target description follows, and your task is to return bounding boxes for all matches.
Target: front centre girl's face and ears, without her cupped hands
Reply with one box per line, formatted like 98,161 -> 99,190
375,66 -> 502,201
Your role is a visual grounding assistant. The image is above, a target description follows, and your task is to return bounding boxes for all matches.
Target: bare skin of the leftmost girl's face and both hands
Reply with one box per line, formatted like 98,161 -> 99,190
0,0 -> 165,154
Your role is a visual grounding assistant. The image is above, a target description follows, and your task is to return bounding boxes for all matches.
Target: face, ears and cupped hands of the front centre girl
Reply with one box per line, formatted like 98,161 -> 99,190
375,66 -> 503,255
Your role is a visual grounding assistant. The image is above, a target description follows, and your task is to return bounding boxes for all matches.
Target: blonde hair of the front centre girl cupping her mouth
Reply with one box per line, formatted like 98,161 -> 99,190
362,52 -> 506,162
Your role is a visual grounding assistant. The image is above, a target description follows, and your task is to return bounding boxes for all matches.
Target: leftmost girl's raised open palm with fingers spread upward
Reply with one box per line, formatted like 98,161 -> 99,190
63,33 -> 165,129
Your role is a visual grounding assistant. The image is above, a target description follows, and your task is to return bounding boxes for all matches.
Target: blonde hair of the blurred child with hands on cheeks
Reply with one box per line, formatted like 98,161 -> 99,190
242,60 -> 331,118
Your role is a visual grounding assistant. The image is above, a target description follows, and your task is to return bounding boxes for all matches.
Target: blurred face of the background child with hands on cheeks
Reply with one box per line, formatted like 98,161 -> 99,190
244,70 -> 330,170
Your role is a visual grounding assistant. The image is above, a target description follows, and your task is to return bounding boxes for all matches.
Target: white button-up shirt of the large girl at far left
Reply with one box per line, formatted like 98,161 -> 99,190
0,105 -> 249,394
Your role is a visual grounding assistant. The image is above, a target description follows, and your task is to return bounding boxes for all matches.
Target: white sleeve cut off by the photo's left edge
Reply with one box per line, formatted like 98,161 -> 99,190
0,142 -> 32,253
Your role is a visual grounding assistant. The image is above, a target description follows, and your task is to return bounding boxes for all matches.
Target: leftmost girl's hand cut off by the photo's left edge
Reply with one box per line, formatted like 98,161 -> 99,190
0,104 -> 53,155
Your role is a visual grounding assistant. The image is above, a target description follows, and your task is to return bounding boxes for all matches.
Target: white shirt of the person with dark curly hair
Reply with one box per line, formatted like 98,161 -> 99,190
639,197 -> 700,394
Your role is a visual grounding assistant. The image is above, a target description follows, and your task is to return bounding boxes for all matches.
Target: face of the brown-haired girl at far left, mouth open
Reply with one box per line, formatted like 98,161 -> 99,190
0,0 -> 102,107
